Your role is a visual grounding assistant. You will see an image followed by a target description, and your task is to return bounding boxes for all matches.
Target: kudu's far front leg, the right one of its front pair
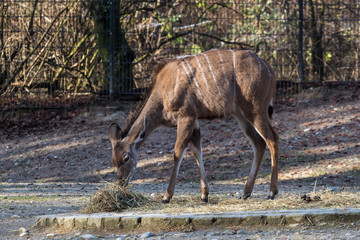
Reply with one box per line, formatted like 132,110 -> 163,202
190,122 -> 209,202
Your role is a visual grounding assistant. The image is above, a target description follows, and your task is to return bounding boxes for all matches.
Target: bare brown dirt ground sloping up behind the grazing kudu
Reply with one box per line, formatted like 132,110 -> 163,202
0,87 -> 360,239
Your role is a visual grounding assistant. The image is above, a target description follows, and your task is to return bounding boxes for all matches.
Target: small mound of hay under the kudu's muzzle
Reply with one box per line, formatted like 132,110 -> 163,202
83,183 -> 150,213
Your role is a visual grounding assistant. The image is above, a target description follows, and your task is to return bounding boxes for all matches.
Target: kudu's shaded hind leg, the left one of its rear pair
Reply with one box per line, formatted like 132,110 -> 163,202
235,116 -> 266,199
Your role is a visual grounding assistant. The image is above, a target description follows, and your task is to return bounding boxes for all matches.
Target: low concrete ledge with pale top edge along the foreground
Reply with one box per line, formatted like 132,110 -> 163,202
36,208 -> 360,232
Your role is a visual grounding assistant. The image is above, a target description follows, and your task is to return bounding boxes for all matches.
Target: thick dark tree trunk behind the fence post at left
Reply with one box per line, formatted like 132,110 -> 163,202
90,0 -> 135,94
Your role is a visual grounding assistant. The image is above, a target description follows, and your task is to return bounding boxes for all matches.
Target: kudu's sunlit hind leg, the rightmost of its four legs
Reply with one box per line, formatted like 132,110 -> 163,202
254,116 -> 279,199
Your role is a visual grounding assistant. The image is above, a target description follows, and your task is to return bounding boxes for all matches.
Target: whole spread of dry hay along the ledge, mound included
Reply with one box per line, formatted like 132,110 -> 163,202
82,183 -> 360,214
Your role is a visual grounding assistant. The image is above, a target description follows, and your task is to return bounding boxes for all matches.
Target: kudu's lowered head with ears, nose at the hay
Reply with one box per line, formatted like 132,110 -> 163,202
109,121 -> 145,186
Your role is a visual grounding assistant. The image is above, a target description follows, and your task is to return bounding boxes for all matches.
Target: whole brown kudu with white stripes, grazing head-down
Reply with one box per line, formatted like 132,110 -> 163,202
109,49 -> 279,202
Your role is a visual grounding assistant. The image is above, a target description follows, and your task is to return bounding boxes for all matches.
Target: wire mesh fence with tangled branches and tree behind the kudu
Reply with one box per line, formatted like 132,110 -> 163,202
0,0 -> 360,109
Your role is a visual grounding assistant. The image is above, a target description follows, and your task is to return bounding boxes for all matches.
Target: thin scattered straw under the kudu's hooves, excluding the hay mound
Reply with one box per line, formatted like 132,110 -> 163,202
117,190 -> 360,214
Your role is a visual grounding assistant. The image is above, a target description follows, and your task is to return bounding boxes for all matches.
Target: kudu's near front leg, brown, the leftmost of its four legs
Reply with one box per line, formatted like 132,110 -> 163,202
162,117 -> 196,203
